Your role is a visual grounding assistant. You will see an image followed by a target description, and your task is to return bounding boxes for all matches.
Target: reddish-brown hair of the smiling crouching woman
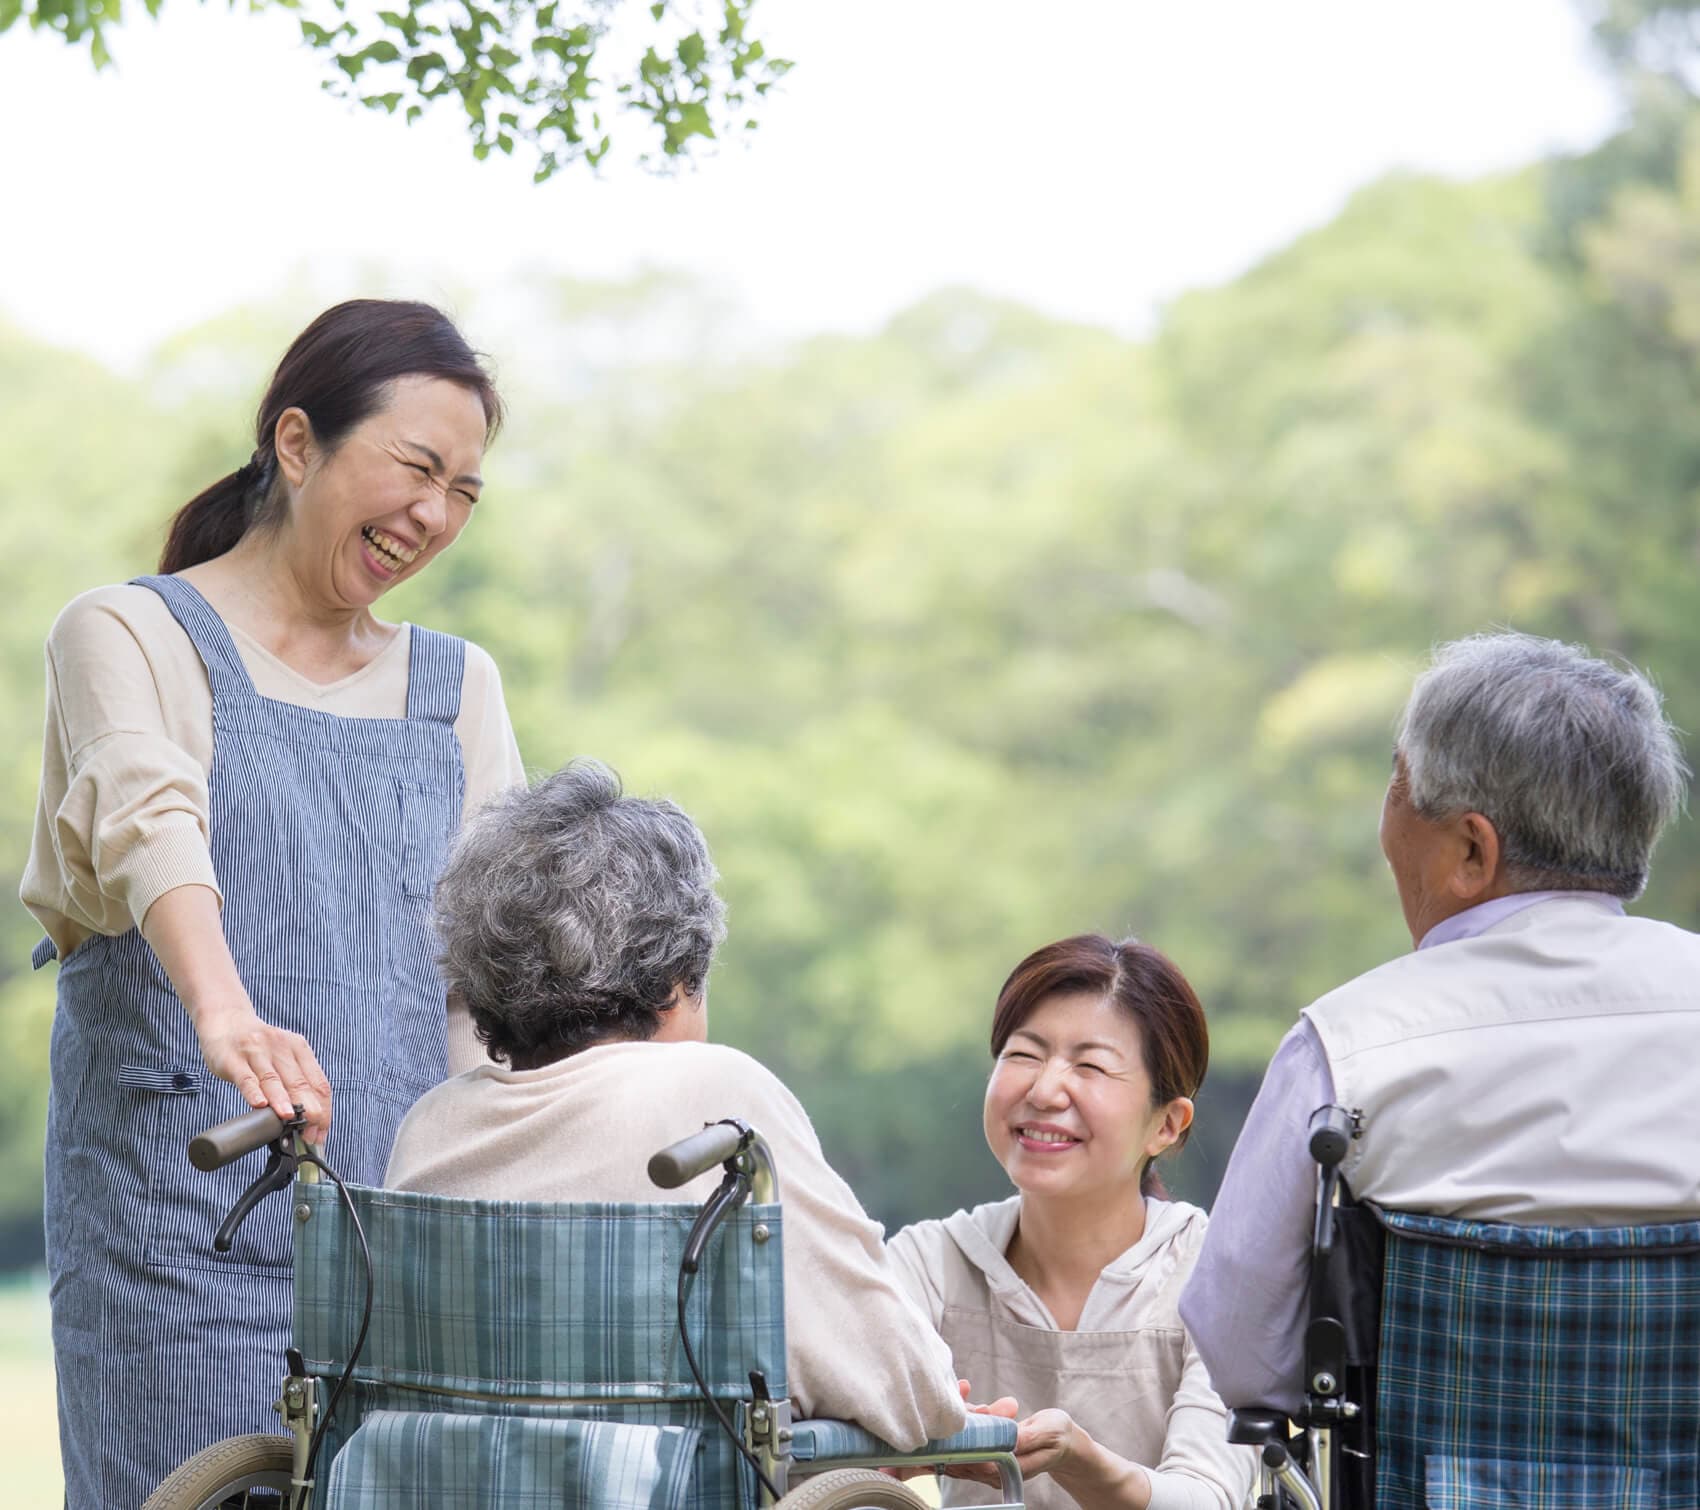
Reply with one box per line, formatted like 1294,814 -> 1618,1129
991,934 -> 1210,1197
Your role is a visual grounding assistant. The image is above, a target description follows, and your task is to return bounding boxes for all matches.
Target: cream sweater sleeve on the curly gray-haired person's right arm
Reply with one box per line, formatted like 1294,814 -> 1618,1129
734,1061 -> 967,1450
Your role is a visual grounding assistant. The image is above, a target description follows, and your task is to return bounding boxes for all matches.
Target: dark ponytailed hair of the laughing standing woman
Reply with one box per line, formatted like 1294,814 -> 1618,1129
160,299 -> 502,573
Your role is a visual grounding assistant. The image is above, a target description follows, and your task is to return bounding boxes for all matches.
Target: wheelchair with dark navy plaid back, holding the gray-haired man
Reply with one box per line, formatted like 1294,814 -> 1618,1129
1227,1105 -> 1700,1510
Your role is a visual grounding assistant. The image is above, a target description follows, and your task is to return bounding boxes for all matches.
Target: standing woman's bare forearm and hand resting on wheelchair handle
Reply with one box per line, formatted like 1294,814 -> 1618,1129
141,886 -> 330,1143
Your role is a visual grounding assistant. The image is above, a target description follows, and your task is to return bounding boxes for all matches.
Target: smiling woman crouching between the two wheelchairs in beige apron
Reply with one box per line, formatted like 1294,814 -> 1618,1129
891,934 -> 1256,1510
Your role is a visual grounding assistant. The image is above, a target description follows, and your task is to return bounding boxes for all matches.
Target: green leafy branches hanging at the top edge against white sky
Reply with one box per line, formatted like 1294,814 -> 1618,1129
0,0 -> 791,182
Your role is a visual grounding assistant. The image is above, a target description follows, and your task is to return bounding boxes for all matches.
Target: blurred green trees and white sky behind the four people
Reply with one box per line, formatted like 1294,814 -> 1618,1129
0,0 -> 1700,1505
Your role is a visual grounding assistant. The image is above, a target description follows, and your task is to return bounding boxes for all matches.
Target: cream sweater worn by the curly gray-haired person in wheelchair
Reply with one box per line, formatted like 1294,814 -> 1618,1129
384,1042 -> 966,1450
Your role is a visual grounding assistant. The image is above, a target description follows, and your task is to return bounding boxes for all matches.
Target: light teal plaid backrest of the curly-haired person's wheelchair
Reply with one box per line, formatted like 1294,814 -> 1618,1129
294,1184 -> 787,1510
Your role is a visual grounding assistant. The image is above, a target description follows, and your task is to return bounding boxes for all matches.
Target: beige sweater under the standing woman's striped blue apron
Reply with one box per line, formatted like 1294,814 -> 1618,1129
19,585 -> 525,1070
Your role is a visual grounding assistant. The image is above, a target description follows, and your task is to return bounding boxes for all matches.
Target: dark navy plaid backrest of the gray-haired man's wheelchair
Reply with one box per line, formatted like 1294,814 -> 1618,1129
1375,1212 -> 1700,1510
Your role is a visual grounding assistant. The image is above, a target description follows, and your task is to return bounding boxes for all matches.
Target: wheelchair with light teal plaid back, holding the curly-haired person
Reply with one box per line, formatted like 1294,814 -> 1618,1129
143,1110 -> 1022,1510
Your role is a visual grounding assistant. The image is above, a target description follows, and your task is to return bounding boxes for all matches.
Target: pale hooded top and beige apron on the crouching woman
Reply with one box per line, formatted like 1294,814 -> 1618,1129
887,1195 -> 1256,1510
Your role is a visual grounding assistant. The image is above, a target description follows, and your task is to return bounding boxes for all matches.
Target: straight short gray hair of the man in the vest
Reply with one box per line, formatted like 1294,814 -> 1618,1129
1399,634 -> 1688,898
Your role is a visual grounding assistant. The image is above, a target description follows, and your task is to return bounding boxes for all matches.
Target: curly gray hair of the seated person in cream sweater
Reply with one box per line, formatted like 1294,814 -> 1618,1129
437,760 -> 726,1068
